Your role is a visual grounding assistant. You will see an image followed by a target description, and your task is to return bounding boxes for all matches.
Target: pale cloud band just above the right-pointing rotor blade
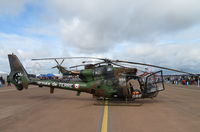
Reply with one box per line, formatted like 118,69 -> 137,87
114,43 -> 200,73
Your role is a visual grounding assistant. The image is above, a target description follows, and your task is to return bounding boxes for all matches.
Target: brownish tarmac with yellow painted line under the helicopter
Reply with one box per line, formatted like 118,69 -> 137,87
0,84 -> 200,132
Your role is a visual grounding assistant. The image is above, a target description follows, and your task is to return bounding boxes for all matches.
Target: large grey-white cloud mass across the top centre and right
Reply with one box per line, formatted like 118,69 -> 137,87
46,0 -> 200,53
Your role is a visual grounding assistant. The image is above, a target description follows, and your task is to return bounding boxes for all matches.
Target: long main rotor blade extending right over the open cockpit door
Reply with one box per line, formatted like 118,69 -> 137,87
114,60 -> 195,75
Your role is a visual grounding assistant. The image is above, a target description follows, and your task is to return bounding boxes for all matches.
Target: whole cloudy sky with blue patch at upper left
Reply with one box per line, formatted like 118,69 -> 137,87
0,0 -> 200,73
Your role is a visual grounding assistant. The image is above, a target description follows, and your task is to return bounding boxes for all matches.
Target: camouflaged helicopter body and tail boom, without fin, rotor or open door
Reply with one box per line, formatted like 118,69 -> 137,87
25,65 -> 163,99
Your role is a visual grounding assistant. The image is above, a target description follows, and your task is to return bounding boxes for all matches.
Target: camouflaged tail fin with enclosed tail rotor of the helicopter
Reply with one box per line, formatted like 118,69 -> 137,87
8,54 -> 29,90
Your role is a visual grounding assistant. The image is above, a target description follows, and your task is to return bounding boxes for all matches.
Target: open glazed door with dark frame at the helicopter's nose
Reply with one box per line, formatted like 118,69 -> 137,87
145,71 -> 165,93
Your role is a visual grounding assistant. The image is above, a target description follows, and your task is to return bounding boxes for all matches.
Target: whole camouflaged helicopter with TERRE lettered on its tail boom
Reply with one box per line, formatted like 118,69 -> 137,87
8,54 -> 194,100
